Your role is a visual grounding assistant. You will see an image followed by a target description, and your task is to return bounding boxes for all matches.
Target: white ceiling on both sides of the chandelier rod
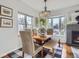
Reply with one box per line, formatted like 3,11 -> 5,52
22,0 -> 79,11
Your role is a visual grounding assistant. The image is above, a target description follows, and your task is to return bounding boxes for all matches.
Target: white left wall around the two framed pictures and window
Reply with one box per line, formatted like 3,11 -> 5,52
0,0 -> 37,57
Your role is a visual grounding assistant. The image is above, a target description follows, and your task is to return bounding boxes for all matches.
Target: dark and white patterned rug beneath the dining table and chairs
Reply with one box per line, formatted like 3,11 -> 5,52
2,44 -> 62,58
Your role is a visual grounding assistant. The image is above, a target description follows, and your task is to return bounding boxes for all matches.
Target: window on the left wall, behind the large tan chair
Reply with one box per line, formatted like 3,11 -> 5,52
18,13 -> 33,34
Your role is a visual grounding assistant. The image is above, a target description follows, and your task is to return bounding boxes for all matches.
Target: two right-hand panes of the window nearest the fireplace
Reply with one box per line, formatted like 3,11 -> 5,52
52,16 -> 65,35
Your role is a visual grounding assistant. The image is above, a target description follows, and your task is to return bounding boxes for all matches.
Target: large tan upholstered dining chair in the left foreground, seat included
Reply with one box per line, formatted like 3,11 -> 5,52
20,29 -> 42,57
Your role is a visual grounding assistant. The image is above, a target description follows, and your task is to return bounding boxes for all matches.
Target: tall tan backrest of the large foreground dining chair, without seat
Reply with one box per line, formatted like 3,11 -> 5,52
20,29 -> 34,55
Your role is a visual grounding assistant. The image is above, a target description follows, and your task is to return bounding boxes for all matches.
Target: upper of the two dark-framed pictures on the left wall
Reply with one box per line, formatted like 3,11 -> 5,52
0,5 -> 13,17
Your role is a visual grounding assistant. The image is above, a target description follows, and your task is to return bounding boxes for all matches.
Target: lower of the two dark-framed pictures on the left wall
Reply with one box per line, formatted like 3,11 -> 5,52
0,17 -> 13,28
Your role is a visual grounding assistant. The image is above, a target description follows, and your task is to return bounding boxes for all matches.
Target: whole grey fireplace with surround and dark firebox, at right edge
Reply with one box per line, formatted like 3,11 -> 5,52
66,24 -> 79,46
